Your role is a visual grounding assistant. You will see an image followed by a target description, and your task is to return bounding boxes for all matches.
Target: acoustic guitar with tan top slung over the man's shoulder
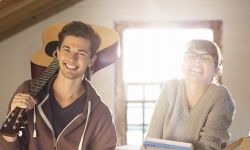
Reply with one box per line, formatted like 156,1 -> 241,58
0,23 -> 119,136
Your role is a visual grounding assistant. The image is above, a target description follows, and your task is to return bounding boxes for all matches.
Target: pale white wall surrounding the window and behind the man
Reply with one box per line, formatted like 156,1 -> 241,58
0,0 -> 250,143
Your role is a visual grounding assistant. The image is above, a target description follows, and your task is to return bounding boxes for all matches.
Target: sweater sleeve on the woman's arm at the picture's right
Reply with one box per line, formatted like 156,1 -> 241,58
195,88 -> 235,150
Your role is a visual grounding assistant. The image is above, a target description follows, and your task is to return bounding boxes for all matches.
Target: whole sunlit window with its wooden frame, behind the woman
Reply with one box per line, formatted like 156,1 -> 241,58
116,19 -> 220,145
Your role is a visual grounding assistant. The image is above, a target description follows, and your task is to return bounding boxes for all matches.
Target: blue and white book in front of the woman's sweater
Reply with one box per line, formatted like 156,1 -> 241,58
143,138 -> 193,150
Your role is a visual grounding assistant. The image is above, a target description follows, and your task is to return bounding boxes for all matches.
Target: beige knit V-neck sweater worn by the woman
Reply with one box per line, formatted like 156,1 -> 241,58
142,79 -> 235,150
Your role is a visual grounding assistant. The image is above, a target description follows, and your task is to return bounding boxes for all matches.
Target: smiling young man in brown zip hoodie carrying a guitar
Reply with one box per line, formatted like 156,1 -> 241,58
0,21 -> 116,150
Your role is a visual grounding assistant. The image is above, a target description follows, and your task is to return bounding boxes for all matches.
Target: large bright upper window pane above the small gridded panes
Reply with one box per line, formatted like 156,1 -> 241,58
123,28 -> 213,83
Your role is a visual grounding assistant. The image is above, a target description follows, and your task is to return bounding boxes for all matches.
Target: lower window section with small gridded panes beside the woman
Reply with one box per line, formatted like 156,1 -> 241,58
125,82 -> 161,145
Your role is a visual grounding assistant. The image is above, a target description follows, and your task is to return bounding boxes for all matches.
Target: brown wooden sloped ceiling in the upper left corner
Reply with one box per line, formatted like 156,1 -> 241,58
0,0 -> 82,41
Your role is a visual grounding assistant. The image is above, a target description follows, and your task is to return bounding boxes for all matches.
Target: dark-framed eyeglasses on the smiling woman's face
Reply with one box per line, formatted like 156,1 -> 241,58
185,52 -> 214,64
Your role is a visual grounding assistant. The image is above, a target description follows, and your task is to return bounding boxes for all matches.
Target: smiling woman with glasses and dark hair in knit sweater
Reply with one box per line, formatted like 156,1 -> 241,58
141,40 -> 235,150
